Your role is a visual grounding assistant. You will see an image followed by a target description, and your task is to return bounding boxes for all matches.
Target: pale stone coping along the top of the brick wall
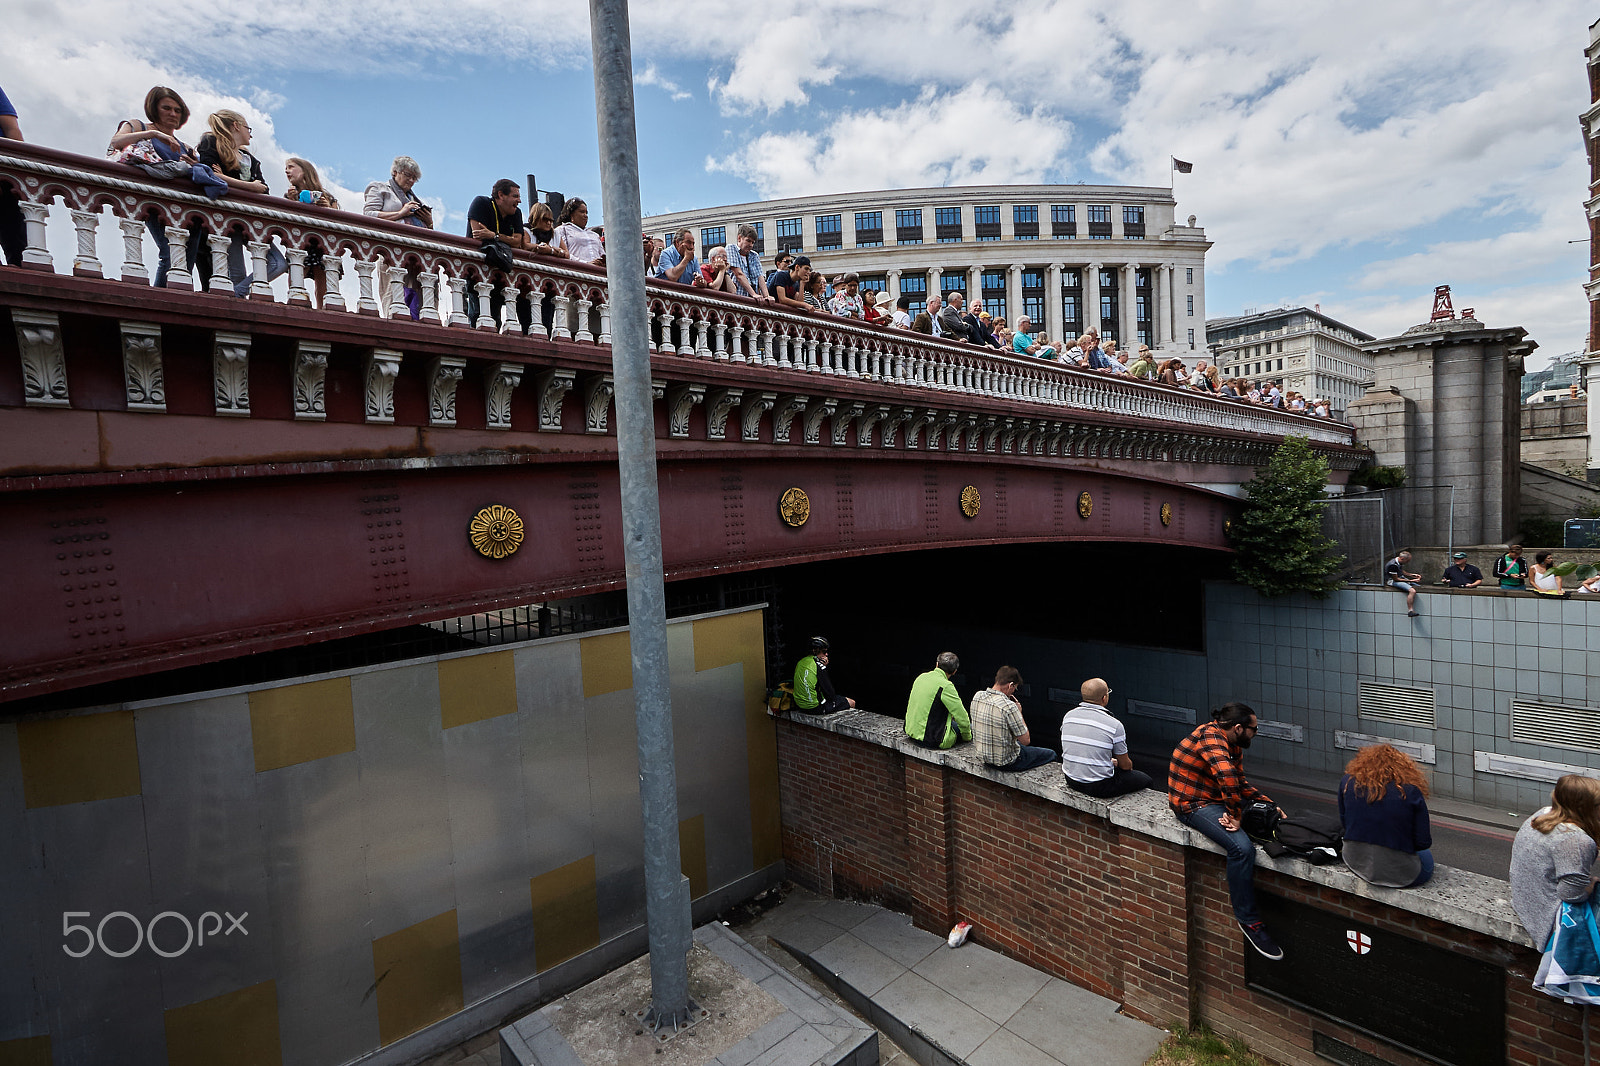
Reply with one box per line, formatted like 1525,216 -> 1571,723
784,711 -> 1538,949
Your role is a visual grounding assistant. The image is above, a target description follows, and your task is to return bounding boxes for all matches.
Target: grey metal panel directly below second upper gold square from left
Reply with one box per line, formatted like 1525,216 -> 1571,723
256,752 -> 378,1066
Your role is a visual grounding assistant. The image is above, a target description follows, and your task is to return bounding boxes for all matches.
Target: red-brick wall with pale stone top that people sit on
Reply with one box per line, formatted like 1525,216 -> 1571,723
778,715 -> 1584,1066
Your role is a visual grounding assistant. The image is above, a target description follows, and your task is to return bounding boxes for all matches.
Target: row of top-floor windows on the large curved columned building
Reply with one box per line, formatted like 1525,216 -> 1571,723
701,203 -> 1158,252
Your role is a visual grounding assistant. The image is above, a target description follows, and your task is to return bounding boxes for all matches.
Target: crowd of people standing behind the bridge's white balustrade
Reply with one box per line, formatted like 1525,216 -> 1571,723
0,85 -> 1330,418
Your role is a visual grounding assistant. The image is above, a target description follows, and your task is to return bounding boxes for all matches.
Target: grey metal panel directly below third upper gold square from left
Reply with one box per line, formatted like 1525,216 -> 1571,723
443,712 -> 534,1004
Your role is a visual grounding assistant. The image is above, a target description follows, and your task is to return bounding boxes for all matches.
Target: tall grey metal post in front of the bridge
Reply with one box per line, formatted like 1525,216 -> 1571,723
589,0 -> 693,1029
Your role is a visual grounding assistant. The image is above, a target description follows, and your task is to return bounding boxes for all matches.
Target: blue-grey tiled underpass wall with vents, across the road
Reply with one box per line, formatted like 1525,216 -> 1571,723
869,581 -> 1600,812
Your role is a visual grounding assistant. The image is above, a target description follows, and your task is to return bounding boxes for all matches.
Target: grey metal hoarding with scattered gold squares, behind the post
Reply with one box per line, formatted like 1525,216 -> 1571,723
0,608 -> 781,1066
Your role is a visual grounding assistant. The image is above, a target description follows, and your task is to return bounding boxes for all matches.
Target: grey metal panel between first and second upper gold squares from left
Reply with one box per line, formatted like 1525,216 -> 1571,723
134,693 -> 274,1008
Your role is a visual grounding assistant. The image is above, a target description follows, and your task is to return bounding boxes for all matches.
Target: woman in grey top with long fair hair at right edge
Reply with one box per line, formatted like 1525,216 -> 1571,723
1510,773 -> 1600,951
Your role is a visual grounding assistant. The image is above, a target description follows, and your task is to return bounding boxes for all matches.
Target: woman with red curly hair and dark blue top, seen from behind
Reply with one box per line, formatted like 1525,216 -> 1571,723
1339,744 -> 1434,888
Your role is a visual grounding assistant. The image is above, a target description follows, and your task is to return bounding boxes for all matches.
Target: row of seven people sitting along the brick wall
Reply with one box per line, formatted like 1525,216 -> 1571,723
794,637 -> 1600,994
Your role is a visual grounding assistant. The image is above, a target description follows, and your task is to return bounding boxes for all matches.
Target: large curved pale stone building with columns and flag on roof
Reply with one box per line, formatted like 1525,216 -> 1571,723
645,186 -> 1211,348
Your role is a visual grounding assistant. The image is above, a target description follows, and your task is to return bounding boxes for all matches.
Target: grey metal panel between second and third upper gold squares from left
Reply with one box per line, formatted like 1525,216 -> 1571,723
350,663 -> 456,940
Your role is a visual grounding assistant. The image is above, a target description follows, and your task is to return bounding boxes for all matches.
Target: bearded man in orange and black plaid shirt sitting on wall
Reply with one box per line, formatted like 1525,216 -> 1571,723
1166,703 -> 1283,960
